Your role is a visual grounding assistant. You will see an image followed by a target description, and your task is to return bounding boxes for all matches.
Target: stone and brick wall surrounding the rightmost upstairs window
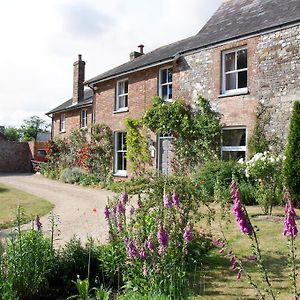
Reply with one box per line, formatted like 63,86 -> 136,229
174,26 -> 300,149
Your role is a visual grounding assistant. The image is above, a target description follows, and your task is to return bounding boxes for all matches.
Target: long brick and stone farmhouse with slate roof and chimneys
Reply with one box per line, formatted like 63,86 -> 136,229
48,0 -> 300,176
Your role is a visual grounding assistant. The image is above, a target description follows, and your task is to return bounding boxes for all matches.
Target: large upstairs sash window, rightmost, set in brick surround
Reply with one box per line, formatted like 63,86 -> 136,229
222,48 -> 248,94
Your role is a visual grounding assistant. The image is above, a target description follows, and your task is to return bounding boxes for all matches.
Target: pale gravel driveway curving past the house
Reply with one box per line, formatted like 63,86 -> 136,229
0,174 -> 114,245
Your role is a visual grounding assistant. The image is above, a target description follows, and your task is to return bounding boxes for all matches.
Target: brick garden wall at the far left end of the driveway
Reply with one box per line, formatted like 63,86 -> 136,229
0,139 -> 32,173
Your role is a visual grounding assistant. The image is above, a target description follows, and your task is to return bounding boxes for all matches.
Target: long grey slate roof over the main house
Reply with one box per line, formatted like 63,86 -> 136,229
85,0 -> 300,84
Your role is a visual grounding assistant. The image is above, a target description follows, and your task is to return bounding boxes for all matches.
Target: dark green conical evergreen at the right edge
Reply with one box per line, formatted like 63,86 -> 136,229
283,101 -> 300,205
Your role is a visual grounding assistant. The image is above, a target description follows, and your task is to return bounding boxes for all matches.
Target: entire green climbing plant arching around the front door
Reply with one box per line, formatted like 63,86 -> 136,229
126,97 -> 221,174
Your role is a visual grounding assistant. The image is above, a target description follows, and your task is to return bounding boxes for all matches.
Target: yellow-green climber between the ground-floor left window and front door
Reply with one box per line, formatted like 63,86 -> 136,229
125,118 -> 150,175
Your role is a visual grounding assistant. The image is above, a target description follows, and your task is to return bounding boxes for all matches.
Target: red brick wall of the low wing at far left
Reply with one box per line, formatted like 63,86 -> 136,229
52,106 -> 92,138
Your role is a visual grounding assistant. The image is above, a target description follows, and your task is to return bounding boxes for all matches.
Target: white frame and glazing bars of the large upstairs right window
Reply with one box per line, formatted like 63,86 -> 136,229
222,47 -> 248,95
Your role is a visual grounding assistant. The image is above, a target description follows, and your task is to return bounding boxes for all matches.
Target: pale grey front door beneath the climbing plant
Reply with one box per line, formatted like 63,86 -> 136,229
158,137 -> 172,175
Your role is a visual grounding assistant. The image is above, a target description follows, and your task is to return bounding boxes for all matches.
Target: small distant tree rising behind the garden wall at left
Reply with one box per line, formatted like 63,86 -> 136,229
20,116 -> 49,141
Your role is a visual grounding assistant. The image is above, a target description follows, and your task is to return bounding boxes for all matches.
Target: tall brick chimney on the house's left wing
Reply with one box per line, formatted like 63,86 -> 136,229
72,54 -> 85,104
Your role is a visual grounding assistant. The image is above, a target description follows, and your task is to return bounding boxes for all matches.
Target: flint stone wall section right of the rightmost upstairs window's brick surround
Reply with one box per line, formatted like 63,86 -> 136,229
257,26 -> 300,144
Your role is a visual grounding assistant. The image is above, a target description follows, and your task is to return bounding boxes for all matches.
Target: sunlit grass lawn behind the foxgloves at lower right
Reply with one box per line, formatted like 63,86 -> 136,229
193,206 -> 300,300
